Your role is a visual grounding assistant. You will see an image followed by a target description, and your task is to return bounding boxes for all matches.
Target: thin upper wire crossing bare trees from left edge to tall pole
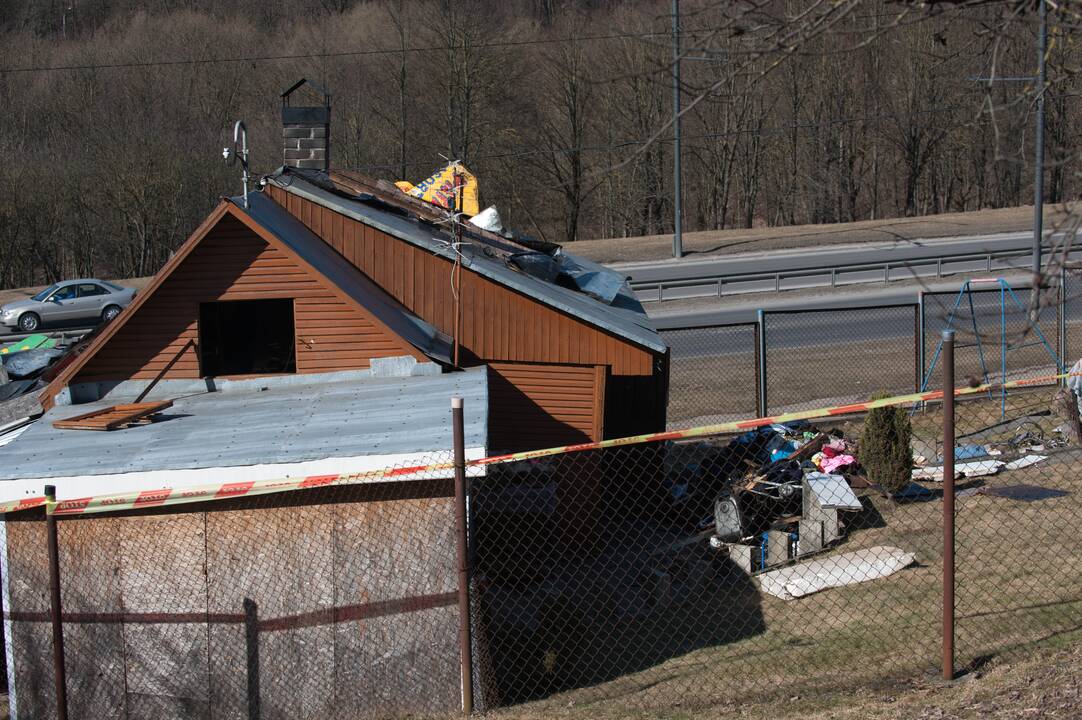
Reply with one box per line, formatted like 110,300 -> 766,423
0,29 -> 727,75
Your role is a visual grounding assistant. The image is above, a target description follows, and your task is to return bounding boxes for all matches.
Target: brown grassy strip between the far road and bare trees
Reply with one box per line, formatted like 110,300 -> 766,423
568,206 -> 1066,263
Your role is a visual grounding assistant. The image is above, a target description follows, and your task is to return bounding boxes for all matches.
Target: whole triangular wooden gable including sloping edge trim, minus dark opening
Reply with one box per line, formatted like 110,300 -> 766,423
41,200 -> 446,407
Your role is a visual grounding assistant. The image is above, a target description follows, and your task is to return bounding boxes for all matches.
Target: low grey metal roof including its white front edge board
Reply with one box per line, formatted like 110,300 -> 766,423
0,368 -> 488,500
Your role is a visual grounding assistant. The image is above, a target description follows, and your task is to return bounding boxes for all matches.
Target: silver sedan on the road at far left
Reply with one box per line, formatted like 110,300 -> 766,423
0,279 -> 135,332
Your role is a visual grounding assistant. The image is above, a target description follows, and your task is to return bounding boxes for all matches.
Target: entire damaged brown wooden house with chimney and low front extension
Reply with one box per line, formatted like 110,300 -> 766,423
0,82 -> 668,718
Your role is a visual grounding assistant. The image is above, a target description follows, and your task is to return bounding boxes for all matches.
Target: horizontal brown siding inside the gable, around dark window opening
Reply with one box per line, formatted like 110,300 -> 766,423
74,215 -> 423,382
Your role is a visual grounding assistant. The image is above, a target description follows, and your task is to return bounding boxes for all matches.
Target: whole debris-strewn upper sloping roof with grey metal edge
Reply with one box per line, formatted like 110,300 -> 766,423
262,168 -> 668,353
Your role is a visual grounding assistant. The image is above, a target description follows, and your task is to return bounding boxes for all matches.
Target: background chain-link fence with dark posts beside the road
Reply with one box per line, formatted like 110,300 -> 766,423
662,275 -> 1069,429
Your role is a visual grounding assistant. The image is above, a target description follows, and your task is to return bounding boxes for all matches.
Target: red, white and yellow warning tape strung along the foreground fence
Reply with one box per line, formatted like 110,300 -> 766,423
0,374 -> 1070,515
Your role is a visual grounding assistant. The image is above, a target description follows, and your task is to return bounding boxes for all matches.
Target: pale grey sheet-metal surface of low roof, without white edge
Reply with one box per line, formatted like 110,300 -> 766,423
0,368 -> 488,480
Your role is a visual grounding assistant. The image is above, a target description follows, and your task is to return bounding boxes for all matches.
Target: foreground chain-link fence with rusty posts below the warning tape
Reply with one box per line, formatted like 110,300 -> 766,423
2,365 -> 1082,720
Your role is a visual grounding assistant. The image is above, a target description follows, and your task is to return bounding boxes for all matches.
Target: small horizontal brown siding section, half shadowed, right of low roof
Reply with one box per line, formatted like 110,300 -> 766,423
488,363 -> 606,453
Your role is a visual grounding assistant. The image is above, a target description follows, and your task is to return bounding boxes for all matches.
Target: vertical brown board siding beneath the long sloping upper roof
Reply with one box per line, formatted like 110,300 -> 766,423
266,185 -> 668,437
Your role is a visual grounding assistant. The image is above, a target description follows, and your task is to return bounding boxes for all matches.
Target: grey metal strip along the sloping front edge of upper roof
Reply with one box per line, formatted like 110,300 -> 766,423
262,172 -> 667,353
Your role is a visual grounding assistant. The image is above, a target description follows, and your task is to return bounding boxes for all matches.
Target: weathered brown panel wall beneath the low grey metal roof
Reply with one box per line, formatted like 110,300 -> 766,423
3,480 -> 460,720
